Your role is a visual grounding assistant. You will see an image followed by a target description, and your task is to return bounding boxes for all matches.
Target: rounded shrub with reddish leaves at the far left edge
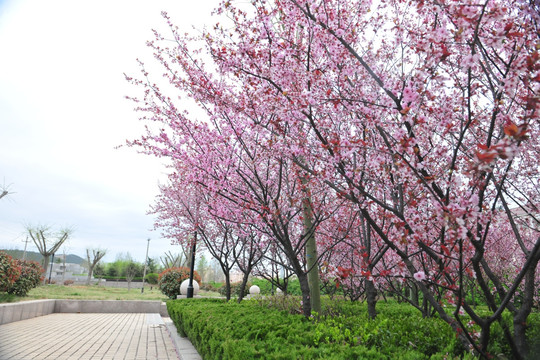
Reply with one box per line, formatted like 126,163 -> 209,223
0,251 -> 43,296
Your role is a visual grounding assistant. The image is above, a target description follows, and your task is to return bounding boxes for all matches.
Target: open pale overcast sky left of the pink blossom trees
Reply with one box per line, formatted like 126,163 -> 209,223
0,0 -> 217,261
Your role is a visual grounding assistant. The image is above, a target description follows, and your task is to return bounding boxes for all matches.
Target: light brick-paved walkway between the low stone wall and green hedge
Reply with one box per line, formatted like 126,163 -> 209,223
0,313 -> 201,360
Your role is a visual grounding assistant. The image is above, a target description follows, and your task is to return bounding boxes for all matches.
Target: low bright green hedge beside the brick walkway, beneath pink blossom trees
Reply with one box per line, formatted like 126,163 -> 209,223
167,299 -> 474,359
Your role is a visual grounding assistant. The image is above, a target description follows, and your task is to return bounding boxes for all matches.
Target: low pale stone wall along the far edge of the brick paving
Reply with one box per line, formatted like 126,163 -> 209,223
0,299 -> 169,325
